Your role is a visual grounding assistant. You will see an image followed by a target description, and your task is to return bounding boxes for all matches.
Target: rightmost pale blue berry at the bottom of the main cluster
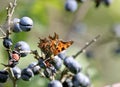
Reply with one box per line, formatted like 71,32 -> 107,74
72,73 -> 90,87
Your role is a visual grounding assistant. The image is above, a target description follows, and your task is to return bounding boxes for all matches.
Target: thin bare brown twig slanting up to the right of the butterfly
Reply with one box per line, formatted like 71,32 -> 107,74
73,35 -> 100,58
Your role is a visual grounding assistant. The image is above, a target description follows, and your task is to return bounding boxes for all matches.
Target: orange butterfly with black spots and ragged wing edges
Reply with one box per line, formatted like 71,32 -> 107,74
38,33 -> 73,57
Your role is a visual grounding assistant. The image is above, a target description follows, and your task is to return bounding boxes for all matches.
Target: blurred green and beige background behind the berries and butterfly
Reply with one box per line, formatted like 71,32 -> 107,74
0,0 -> 120,87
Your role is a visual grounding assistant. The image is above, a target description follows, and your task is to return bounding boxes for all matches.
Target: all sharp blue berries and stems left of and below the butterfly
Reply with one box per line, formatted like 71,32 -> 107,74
0,17 -> 90,87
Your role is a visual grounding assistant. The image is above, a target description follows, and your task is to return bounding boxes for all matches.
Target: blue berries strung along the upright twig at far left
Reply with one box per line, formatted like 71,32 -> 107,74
0,14 -> 33,83
